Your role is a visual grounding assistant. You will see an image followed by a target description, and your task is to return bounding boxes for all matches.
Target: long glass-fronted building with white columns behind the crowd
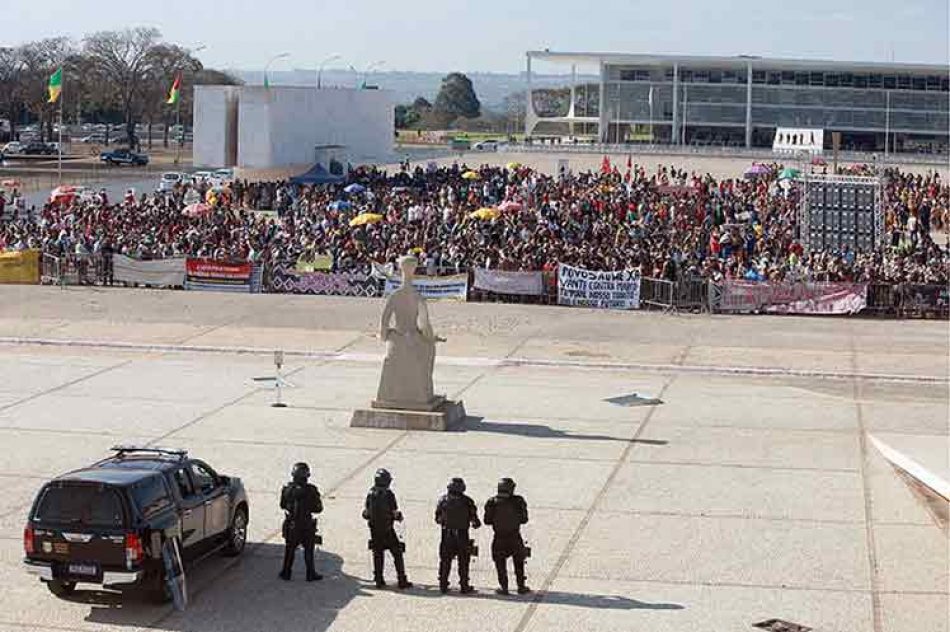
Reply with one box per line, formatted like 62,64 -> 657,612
525,51 -> 950,153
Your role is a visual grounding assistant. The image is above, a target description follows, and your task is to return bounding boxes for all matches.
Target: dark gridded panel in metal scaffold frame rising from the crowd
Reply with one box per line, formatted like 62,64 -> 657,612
798,174 -> 884,252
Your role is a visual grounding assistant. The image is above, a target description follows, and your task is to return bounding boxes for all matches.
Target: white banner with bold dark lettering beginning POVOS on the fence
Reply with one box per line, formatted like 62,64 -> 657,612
557,263 -> 640,309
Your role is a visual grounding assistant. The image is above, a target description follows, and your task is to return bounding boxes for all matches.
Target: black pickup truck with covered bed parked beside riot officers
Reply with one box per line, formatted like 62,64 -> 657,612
23,447 -> 249,599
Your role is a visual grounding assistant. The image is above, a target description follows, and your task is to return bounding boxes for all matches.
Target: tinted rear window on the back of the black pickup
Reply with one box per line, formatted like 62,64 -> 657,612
33,485 -> 123,527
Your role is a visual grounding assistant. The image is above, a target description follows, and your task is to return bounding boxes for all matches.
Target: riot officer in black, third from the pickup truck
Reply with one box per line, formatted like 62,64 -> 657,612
435,478 -> 482,594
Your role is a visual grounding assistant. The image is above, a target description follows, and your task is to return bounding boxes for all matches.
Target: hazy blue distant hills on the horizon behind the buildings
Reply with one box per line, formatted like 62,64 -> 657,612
230,68 -> 597,110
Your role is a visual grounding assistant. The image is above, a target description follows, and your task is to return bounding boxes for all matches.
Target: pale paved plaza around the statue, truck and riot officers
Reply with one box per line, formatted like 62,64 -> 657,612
0,286 -> 950,632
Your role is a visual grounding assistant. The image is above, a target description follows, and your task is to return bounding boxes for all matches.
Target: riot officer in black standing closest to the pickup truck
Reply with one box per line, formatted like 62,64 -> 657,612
279,463 -> 323,582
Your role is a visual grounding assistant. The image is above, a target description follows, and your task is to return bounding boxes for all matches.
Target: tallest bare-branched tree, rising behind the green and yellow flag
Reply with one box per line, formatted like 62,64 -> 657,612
83,27 -> 160,147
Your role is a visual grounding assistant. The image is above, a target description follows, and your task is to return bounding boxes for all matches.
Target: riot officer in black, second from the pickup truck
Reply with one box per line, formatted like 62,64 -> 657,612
363,469 -> 412,588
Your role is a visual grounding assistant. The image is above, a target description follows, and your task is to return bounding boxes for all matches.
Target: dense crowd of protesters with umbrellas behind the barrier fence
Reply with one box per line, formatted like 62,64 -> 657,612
0,160 -> 950,283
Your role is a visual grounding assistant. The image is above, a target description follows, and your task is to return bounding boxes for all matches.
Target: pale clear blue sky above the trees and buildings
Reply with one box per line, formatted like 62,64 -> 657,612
0,0 -> 950,72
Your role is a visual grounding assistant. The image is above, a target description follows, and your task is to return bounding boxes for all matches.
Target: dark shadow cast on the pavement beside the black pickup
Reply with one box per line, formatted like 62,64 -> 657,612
80,543 -> 371,632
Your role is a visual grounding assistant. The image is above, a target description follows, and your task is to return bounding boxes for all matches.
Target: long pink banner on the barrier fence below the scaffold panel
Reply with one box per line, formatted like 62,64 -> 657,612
719,279 -> 868,314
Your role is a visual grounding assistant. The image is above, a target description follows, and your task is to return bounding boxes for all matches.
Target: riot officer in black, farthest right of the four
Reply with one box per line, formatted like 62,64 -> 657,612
485,478 -> 531,595
